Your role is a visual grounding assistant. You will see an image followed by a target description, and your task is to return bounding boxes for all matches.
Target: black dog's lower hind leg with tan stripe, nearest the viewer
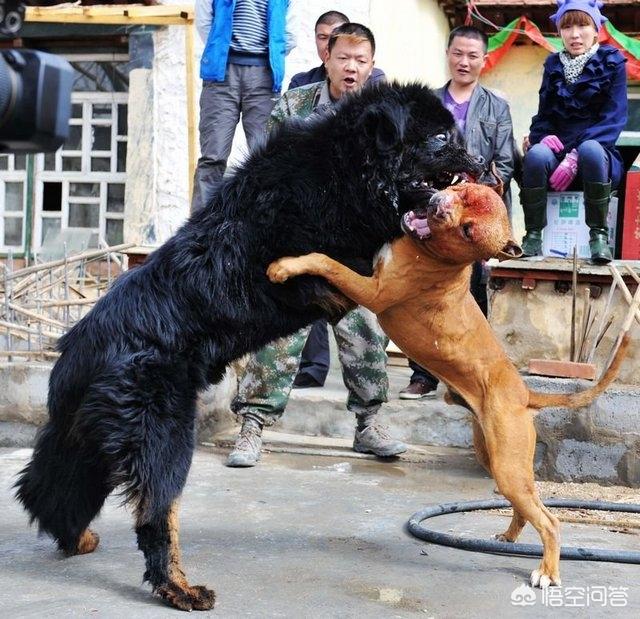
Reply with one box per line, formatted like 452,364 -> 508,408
136,500 -> 216,611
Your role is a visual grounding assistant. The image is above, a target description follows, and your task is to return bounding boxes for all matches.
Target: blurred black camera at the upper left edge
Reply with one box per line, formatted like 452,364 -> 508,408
0,1 -> 73,153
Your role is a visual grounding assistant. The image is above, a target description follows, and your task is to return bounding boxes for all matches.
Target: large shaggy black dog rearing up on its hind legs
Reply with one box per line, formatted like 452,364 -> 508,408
16,85 -> 480,610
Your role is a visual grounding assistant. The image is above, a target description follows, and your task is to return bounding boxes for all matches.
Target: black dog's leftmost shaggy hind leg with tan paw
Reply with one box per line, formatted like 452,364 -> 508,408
15,421 -> 112,555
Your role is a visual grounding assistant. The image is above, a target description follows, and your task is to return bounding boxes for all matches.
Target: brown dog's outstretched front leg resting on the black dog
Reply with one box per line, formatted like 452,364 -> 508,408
267,253 -> 392,314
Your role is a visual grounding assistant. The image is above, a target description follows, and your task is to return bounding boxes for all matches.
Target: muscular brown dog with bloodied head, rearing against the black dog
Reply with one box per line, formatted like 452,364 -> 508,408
268,184 -> 627,587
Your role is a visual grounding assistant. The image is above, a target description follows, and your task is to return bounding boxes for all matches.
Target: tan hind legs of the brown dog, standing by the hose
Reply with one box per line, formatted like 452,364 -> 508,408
482,408 -> 560,587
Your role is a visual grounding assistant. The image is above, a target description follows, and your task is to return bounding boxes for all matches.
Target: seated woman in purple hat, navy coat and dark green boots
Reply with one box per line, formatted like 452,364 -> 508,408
520,0 -> 627,264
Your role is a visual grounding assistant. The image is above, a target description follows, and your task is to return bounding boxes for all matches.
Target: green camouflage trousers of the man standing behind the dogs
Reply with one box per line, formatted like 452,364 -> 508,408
232,307 -> 389,426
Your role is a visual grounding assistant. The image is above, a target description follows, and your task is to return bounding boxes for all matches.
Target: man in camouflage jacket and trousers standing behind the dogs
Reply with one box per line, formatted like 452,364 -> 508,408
227,23 -> 406,467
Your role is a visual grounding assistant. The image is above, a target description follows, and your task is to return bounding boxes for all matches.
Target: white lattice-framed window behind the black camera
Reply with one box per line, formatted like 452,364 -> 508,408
0,54 -> 129,254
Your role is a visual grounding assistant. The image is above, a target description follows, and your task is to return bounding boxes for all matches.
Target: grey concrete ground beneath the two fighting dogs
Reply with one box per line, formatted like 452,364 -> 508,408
0,445 -> 640,619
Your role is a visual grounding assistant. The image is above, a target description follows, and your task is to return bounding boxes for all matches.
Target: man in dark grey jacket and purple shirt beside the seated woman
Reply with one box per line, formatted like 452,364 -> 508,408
400,26 -> 519,400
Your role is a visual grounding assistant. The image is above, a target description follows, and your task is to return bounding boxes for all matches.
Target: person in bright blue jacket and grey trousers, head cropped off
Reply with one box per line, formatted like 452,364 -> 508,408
192,0 -> 295,210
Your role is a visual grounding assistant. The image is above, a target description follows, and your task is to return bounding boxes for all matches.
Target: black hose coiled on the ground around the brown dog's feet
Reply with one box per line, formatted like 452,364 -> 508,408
407,499 -> 640,563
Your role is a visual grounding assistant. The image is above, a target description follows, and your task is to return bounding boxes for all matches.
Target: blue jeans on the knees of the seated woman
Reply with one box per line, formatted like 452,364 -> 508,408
522,140 -> 610,190
